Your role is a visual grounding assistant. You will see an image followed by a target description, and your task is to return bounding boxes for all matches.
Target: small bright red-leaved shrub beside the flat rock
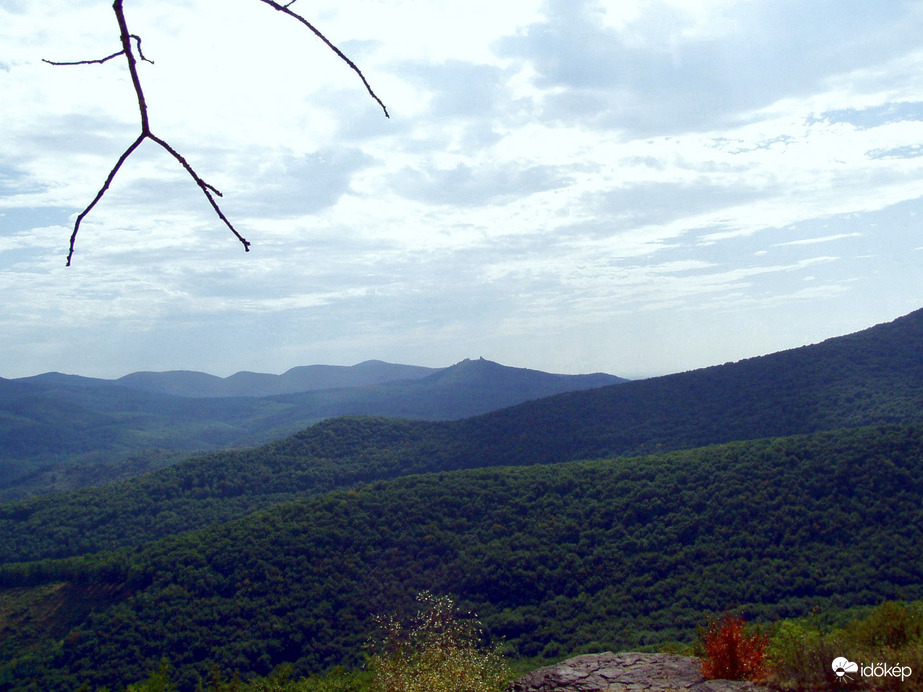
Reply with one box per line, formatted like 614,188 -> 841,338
702,615 -> 769,680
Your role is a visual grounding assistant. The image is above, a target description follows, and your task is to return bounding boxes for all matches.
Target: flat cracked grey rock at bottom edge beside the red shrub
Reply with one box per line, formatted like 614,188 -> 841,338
507,652 -> 768,692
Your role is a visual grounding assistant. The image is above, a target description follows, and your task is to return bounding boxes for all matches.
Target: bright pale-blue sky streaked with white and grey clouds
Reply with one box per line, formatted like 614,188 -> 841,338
0,0 -> 923,378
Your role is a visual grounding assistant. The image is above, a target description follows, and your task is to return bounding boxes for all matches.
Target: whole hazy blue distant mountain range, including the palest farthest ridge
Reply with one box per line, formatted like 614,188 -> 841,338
0,359 -> 625,498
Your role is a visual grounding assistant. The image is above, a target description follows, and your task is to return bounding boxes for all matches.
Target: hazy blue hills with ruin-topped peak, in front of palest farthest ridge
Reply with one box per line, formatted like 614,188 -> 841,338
0,360 -> 619,490
